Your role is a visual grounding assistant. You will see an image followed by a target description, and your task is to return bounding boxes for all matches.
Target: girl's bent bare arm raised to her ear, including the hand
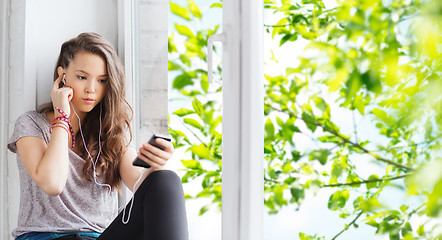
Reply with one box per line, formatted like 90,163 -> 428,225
16,74 -> 73,196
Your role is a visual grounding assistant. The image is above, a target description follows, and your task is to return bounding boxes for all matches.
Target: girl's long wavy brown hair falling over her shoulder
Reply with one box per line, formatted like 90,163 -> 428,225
38,33 -> 133,189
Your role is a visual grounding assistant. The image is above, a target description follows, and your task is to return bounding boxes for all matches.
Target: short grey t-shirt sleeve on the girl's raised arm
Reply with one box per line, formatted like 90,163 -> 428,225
7,112 -> 45,153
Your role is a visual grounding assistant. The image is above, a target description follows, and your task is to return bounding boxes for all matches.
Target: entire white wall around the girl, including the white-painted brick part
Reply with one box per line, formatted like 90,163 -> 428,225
0,0 -> 168,239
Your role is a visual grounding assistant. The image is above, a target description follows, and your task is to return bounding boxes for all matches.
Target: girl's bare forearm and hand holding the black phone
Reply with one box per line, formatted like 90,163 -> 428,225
120,138 -> 173,192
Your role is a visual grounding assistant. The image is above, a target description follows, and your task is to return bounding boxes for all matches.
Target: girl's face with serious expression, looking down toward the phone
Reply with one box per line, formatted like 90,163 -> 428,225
59,51 -> 107,113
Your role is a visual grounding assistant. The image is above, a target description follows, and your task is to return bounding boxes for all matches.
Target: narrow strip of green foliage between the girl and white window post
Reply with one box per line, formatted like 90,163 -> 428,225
169,0 -> 222,215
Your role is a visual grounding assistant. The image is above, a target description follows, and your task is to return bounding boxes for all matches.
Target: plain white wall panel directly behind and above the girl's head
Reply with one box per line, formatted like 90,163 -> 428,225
25,0 -> 118,105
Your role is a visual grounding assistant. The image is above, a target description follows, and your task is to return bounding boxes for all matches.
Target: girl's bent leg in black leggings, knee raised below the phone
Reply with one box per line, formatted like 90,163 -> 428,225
98,170 -> 188,240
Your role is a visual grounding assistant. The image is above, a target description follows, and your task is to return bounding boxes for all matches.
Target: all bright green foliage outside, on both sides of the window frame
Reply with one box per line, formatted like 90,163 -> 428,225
169,0 -> 442,239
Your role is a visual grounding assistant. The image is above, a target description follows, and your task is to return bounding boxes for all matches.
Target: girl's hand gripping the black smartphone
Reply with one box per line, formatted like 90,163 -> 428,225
138,138 -> 174,170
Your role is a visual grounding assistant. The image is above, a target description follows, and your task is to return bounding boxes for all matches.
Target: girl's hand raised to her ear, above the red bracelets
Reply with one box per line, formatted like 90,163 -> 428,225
51,74 -> 74,117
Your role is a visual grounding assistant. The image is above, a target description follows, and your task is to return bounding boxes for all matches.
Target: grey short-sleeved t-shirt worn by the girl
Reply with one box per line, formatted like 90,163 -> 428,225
8,111 -> 118,238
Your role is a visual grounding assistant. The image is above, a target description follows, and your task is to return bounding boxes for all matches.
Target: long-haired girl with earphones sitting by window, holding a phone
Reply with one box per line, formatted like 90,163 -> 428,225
8,33 -> 188,240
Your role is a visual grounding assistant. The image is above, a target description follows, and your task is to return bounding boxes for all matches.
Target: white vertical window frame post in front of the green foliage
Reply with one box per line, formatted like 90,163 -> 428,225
222,0 -> 264,240
